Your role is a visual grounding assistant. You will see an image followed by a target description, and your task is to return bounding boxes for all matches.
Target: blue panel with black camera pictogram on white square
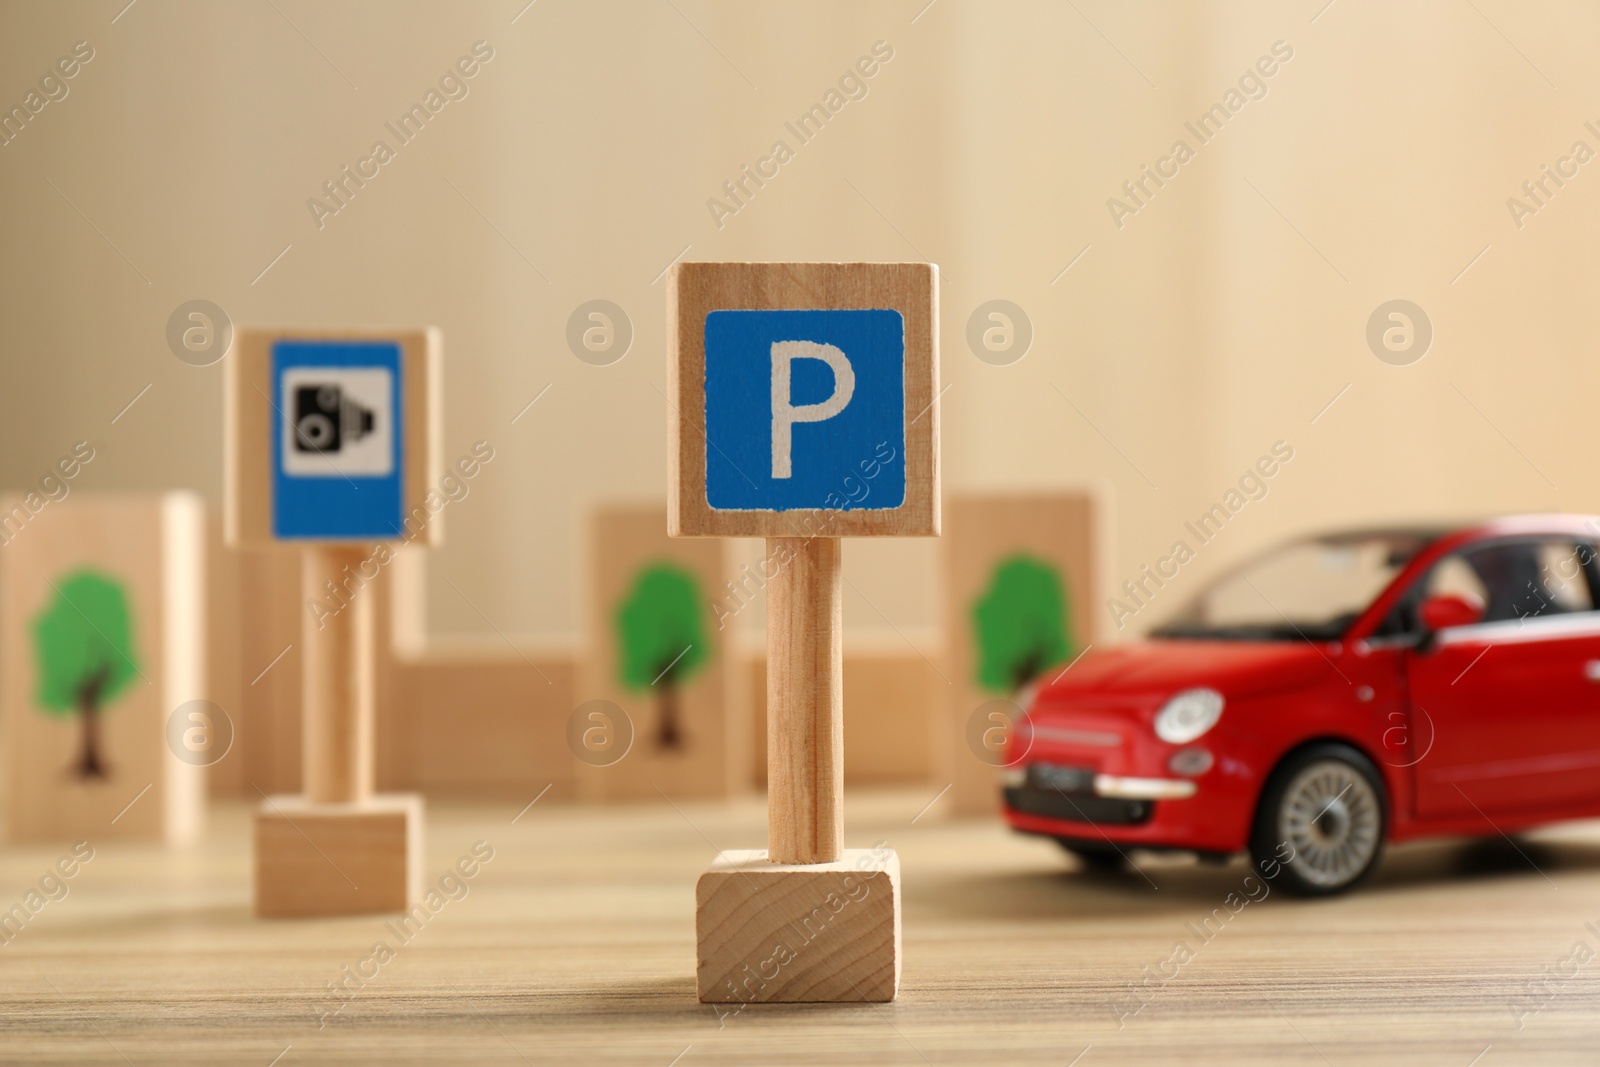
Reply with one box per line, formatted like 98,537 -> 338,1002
272,341 -> 405,541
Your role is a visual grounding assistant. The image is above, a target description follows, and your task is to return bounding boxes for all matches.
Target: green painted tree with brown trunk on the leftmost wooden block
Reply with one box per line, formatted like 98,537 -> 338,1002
34,569 -> 139,779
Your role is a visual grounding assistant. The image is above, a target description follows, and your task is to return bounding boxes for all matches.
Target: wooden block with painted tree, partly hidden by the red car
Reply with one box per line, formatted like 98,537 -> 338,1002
933,490 -> 1104,814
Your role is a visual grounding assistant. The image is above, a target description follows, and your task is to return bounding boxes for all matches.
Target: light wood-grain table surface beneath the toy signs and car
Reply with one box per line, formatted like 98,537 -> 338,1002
0,790 -> 1600,1067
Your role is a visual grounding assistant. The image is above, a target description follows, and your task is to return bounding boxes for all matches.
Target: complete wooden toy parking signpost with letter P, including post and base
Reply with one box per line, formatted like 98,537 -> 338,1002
667,262 -> 939,1003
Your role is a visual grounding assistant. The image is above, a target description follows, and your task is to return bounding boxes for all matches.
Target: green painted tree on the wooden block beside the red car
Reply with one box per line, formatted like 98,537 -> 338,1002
973,555 -> 1074,696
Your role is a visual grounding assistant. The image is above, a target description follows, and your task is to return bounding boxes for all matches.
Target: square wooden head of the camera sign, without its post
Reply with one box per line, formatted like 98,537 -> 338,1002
227,328 -> 442,547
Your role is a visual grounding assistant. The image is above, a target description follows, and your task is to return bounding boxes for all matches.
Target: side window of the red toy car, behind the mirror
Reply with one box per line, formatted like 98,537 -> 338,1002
1374,537 -> 1600,637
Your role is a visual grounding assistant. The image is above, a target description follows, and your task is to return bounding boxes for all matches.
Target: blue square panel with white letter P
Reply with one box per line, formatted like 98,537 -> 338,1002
706,309 -> 906,512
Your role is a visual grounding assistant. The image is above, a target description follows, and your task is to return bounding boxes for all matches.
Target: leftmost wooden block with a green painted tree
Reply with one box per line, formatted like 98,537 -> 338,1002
0,492 -> 209,841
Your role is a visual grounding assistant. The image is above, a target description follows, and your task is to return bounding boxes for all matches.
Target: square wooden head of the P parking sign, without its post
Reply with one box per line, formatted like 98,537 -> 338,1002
667,262 -> 939,537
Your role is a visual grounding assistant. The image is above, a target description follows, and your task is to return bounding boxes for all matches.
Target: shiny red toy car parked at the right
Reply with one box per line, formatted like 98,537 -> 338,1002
1005,515 -> 1600,894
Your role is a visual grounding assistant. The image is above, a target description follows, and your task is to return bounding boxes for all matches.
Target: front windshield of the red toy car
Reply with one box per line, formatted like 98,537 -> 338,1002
1155,533 -> 1432,641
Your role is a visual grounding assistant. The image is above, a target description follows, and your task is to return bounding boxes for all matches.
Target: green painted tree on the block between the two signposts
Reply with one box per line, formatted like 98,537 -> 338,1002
616,561 -> 710,752
